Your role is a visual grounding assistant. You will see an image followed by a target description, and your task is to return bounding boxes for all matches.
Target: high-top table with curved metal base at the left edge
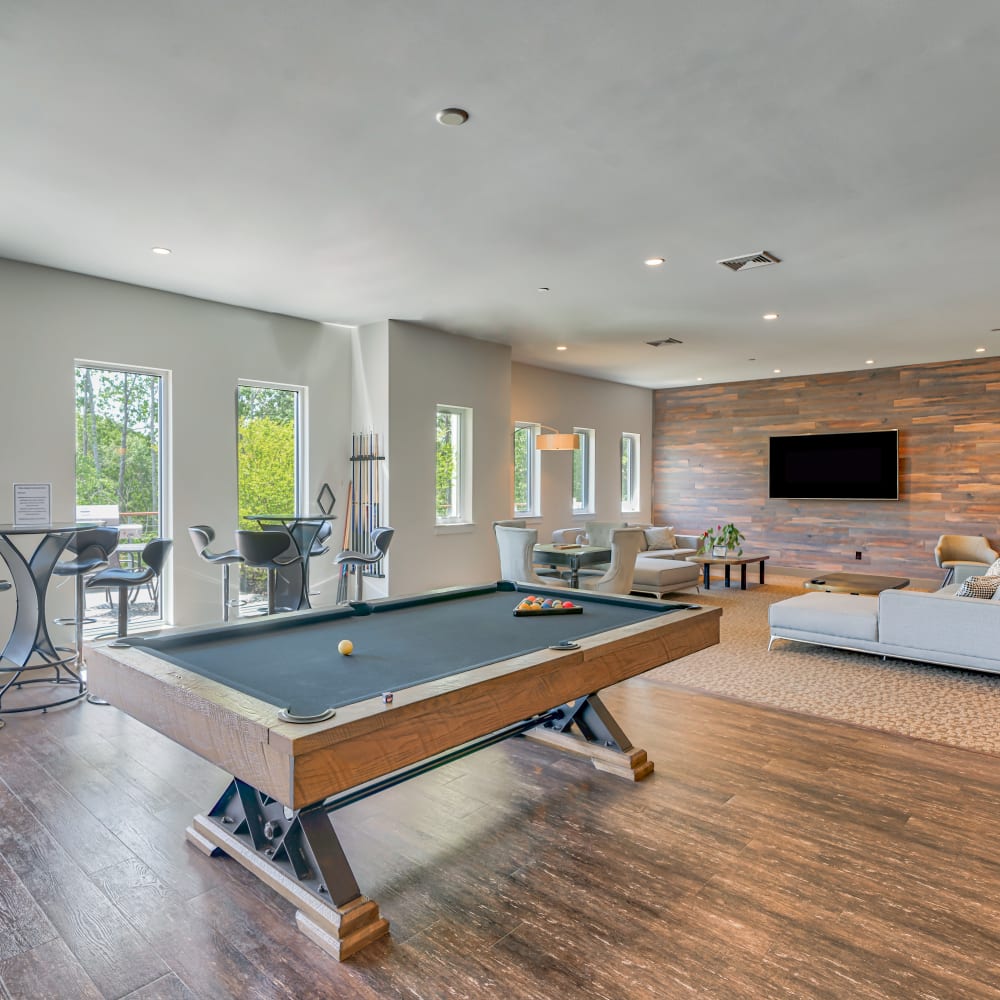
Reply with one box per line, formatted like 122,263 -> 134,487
0,521 -> 97,714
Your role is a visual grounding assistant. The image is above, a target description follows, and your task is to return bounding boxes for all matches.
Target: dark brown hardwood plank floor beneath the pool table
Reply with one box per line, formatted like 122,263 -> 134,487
0,678 -> 1000,1000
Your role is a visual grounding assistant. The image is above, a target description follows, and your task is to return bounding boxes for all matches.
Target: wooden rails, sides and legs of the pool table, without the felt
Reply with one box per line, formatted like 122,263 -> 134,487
87,588 -> 721,959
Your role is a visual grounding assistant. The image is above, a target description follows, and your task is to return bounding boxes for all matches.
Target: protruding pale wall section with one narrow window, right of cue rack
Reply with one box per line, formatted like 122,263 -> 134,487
387,320 -> 513,594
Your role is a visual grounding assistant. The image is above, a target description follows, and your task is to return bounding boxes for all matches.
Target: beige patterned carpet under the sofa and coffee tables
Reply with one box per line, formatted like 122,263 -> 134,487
644,578 -> 1000,755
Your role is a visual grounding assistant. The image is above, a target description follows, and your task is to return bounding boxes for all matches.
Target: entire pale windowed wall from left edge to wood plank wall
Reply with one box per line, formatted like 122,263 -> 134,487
0,260 -> 652,635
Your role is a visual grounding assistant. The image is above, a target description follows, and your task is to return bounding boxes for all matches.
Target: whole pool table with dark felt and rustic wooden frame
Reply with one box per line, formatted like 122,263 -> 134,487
87,581 -> 721,959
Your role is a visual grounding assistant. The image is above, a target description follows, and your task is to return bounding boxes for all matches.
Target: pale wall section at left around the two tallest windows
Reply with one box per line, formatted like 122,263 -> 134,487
0,260 -> 351,633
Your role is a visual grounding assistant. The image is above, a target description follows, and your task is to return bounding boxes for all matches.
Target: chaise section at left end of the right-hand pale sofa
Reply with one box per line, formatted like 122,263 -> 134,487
767,591 -> 878,652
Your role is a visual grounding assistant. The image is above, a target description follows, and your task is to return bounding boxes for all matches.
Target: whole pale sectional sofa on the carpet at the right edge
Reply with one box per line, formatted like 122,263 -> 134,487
768,584 -> 1000,673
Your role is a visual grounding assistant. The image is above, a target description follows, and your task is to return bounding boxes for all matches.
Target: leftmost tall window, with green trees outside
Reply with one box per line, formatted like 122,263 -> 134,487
75,364 -> 163,633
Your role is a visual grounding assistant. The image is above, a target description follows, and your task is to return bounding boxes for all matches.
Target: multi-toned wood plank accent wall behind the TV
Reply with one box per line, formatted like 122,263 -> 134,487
653,358 -> 1000,581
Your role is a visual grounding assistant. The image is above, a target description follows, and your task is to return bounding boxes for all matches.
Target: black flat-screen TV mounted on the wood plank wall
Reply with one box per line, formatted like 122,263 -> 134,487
768,430 -> 899,500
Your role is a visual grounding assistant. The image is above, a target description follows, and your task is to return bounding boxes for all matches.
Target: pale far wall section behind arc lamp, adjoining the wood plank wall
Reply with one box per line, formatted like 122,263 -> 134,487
504,364 -> 653,541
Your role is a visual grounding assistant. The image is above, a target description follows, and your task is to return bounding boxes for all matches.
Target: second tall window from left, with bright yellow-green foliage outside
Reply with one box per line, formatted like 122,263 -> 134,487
236,381 -> 304,613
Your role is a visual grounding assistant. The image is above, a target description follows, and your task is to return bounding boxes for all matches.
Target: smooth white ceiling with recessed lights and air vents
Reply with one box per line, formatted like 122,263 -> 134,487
0,0 -> 1000,387
